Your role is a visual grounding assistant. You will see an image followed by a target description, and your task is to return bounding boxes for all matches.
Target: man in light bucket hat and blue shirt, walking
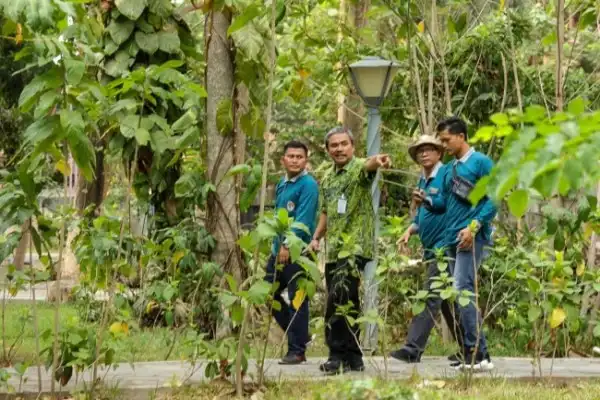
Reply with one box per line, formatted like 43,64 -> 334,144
391,135 -> 461,363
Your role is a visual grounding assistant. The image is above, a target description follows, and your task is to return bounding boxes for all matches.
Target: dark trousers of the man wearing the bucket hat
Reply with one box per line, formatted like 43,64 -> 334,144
404,255 -> 463,358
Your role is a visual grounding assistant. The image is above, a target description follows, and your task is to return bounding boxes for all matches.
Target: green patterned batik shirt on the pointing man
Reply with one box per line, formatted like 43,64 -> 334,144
319,157 -> 376,263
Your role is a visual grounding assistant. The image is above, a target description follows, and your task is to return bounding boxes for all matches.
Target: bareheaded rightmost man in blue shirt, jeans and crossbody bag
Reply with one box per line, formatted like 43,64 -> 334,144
434,117 -> 496,370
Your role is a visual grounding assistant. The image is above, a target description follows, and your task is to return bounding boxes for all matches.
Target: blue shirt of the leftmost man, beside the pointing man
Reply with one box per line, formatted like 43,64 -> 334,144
272,171 -> 319,254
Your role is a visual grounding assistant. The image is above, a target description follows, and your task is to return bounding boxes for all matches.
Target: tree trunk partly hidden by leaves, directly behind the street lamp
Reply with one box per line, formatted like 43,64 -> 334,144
343,0 -> 371,154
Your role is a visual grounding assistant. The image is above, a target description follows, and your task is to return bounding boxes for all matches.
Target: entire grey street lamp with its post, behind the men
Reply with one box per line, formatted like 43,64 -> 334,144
350,57 -> 400,351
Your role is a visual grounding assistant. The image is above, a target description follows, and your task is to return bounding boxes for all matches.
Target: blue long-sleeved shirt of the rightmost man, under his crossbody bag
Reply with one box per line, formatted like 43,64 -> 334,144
432,149 -> 497,246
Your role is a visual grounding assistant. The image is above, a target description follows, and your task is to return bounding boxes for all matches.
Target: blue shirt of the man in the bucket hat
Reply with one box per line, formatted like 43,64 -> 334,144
413,162 -> 447,250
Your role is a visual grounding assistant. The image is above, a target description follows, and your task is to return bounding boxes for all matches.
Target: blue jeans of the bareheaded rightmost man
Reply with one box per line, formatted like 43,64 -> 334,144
447,237 -> 489,354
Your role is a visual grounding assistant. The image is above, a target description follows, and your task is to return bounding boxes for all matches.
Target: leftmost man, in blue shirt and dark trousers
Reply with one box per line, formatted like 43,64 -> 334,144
265,141 -> 319,365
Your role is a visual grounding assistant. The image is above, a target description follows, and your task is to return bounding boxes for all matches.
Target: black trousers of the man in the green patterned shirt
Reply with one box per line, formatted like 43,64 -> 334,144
325,256 -> 369,361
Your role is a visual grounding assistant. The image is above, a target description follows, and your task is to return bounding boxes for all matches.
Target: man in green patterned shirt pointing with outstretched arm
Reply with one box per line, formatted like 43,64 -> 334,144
310,128 -> 390,374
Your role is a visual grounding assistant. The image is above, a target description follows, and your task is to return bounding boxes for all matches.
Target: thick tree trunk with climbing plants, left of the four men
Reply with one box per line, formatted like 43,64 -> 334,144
204,8 -> 245,336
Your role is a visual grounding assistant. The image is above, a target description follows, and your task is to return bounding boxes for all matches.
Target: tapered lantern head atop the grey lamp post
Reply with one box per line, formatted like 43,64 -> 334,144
350,57 -> 400,107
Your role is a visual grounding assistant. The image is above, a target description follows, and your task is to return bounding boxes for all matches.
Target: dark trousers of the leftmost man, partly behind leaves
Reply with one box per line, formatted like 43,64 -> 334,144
265,256 -> 309,355
